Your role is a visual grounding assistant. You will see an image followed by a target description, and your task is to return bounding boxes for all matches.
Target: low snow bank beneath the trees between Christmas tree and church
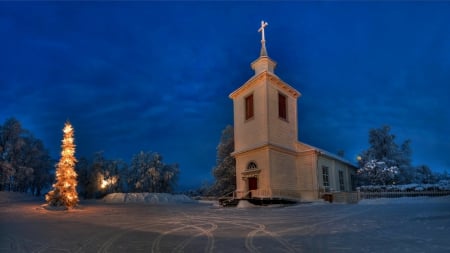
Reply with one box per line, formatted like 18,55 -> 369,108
103,192 -> 195,204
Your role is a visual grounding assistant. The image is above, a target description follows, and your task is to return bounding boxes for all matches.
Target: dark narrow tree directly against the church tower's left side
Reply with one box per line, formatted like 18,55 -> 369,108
211,125 -> 236,196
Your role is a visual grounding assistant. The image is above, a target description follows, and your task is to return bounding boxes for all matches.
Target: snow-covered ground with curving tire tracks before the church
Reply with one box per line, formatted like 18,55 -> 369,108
0,192 -> 450,252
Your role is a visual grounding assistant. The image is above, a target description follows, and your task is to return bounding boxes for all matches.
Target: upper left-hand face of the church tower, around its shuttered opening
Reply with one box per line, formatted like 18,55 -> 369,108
233,82 -> 268,152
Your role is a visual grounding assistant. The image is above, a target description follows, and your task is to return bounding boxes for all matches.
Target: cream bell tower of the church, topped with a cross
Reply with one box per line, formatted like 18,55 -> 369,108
229,21 -> 301,197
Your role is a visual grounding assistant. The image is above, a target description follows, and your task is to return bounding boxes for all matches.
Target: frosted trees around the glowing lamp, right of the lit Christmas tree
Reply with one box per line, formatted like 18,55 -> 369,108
75,151 -> 179,199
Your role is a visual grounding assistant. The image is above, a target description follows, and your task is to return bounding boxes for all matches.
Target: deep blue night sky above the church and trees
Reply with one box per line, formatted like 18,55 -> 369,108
0,1 -> 450,189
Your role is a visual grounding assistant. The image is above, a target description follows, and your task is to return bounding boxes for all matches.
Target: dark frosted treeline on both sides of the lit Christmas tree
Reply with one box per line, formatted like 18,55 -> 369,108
0,118 -> 179,198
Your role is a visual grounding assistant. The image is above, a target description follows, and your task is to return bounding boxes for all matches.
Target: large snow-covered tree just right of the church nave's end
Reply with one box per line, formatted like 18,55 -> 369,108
358,126 -> 413,184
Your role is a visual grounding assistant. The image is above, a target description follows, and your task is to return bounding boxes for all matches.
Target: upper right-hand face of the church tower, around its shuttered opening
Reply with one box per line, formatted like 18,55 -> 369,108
267,82 -> 298,150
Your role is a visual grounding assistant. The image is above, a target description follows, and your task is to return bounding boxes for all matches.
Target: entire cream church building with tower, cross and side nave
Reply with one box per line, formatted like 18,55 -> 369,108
229,22 -> 357,201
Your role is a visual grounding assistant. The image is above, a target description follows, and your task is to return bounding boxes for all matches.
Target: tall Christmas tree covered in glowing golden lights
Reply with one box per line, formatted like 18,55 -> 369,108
45,122 -> 78,208
